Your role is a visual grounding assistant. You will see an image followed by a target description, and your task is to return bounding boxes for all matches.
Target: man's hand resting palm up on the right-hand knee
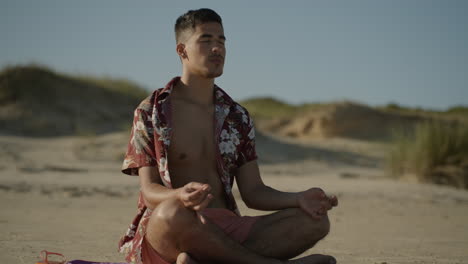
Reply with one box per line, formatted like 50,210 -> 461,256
297,188 -> 338,219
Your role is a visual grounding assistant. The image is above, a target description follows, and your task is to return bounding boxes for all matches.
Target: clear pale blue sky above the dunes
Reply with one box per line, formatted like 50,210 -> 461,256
0,0 -> 468,109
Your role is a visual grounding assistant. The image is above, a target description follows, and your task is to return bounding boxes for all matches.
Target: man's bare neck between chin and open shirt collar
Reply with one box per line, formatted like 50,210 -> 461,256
176,74 -> 214,105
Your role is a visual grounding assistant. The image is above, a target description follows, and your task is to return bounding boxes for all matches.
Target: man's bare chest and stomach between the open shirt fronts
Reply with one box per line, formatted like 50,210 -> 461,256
168,97 -> 227,208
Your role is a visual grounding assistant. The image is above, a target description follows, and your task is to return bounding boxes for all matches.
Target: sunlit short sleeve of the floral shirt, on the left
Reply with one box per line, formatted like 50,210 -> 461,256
122,108 -> 157,176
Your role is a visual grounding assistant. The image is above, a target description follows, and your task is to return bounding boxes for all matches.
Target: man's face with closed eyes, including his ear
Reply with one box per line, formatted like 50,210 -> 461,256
178,22 -> 226,78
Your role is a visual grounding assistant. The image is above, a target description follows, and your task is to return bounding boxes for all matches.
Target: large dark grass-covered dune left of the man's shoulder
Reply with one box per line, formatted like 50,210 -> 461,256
0,64 -> 150,136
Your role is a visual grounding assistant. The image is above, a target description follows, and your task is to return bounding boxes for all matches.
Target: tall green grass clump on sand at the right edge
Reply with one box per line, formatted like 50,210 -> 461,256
387,121 -> 468,189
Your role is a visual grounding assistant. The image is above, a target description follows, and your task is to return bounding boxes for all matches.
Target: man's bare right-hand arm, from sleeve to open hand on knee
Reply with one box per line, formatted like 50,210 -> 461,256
236,160 -> 338,218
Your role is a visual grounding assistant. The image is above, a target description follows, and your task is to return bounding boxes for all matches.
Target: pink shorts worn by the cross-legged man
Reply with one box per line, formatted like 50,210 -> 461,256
141,208 -> 259,264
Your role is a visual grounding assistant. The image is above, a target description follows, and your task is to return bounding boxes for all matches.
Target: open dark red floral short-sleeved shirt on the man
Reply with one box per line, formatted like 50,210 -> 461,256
119,77 -> 257,264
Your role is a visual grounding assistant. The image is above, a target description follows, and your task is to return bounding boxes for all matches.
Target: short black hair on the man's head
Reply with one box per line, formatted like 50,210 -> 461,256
174,8 -> 223,43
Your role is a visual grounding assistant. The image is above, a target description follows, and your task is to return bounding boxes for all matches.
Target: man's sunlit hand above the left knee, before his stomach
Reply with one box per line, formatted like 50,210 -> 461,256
178,182 -> 213,211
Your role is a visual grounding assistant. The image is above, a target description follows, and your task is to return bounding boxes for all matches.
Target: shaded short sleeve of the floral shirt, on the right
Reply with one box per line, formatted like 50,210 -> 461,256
237,111 -> 258,168
